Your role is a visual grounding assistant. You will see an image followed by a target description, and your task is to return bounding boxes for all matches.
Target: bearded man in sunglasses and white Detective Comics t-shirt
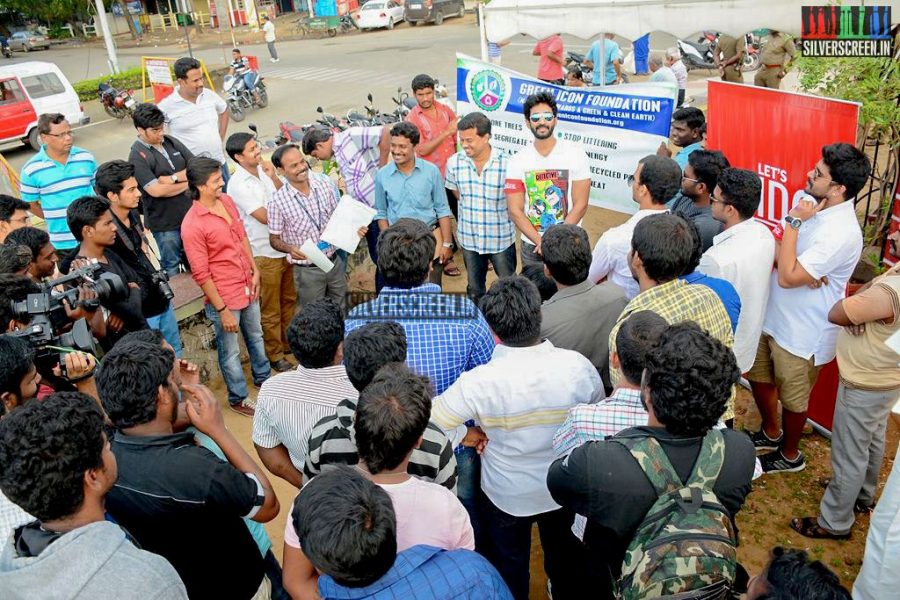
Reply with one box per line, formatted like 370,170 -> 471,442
506,92 -> 591,266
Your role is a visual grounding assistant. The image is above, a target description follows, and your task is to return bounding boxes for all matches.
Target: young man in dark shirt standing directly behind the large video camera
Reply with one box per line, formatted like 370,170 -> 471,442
59,196 -> 147,342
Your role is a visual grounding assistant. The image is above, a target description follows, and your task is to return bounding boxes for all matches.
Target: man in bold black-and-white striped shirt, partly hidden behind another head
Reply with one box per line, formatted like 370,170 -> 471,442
303,321 -> 456,492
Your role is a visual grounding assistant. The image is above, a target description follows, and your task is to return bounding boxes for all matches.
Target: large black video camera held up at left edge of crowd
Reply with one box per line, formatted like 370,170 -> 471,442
10,263 -> 128,367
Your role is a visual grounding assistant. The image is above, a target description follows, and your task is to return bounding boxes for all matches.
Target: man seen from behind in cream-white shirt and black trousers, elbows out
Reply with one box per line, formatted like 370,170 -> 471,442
431,276 -> 604,599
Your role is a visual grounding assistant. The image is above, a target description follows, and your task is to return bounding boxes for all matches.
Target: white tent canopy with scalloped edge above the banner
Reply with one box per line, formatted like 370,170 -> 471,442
484,0 -> 804,42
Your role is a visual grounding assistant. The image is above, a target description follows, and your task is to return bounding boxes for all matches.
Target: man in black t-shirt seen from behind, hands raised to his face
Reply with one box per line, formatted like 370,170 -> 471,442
97,340 -> 279,600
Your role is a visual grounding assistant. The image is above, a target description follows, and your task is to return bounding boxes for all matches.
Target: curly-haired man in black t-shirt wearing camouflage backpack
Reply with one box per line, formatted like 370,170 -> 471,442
547,322 -> 756,598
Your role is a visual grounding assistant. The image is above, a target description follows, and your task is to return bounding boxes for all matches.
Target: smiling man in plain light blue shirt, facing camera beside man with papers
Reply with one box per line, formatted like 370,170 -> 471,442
375,122 -> 453,290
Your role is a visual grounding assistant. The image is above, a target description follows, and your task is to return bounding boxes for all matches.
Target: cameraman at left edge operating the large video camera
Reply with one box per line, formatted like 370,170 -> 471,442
0,274 -> 98,400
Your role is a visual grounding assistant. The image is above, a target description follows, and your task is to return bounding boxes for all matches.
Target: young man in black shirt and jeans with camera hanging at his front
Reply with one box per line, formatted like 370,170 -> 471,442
94,160 -> 182,357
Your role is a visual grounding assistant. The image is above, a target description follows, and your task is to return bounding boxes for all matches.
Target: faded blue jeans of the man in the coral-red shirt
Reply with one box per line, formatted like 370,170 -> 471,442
206,301 -> 272,404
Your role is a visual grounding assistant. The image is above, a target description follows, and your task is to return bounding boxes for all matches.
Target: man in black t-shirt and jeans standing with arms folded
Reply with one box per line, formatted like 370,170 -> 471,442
128,102 -> 193,276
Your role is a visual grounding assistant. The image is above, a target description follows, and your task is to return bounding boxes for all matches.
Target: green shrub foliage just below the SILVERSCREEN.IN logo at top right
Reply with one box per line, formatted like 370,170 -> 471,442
797,52 -> 900,142
